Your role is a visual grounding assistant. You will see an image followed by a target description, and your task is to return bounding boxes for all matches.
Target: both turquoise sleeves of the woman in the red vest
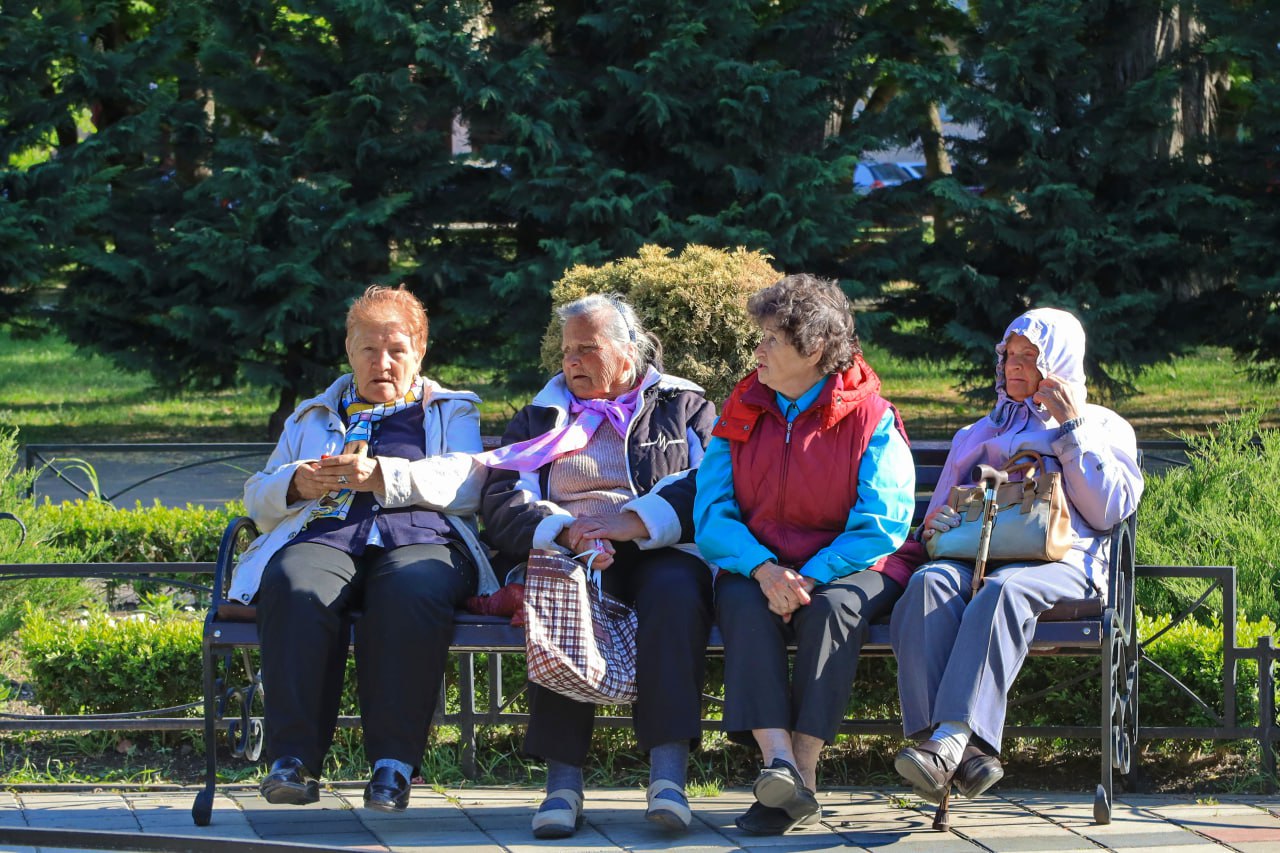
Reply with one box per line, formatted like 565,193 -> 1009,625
694,411 -> 915,583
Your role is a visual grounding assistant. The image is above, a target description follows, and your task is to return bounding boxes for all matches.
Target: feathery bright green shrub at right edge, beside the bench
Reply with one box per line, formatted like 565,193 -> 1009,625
1137,410 -> 1280,621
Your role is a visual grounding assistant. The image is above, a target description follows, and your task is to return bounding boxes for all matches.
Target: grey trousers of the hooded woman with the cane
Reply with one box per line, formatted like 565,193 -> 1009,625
890,560 -> 1097,751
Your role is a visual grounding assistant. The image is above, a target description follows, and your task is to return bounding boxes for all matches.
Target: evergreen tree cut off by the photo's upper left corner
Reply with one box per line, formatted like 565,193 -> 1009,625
0,0 -> 164,324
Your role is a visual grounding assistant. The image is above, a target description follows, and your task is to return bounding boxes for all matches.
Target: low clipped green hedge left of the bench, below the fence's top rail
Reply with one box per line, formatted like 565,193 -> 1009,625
18,608 -> 204,715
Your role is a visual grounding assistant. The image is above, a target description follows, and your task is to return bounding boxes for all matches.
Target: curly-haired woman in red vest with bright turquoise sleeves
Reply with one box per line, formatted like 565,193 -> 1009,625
694,275 -> 915,835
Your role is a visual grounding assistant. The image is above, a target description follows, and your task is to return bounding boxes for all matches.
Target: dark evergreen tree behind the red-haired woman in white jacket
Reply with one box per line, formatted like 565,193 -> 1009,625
38,0 -> 488,432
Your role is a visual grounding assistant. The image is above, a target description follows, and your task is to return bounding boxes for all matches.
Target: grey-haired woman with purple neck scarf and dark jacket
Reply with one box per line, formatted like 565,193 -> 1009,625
483,296 -> 716,838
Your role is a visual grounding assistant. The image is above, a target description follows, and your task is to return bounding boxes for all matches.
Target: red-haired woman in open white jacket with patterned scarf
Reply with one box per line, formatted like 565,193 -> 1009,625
230,286 -> 497,812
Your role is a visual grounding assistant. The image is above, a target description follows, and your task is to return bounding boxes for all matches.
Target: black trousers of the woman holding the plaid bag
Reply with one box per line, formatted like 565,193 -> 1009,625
525,542 -> 712,766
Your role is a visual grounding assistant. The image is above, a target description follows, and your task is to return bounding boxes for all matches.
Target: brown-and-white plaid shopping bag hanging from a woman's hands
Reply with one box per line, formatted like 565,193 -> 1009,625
525,549 -> 636,704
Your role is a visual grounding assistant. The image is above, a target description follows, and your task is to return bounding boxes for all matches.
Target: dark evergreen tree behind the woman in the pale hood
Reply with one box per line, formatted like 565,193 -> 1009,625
865,0 -> 1229,391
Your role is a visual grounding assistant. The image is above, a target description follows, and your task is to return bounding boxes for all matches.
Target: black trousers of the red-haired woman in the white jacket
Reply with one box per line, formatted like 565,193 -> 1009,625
257,542 -> 476,774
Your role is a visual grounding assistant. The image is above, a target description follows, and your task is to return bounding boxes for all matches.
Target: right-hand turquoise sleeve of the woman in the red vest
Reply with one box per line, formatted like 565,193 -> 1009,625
800,410 -> 915,584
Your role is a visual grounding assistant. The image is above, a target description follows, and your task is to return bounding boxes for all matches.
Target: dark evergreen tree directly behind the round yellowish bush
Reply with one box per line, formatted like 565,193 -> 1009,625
471,0 -> 868,379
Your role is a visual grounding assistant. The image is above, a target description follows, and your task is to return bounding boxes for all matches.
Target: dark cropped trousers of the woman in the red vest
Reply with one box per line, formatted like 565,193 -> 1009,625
716,571 -> 902,744
